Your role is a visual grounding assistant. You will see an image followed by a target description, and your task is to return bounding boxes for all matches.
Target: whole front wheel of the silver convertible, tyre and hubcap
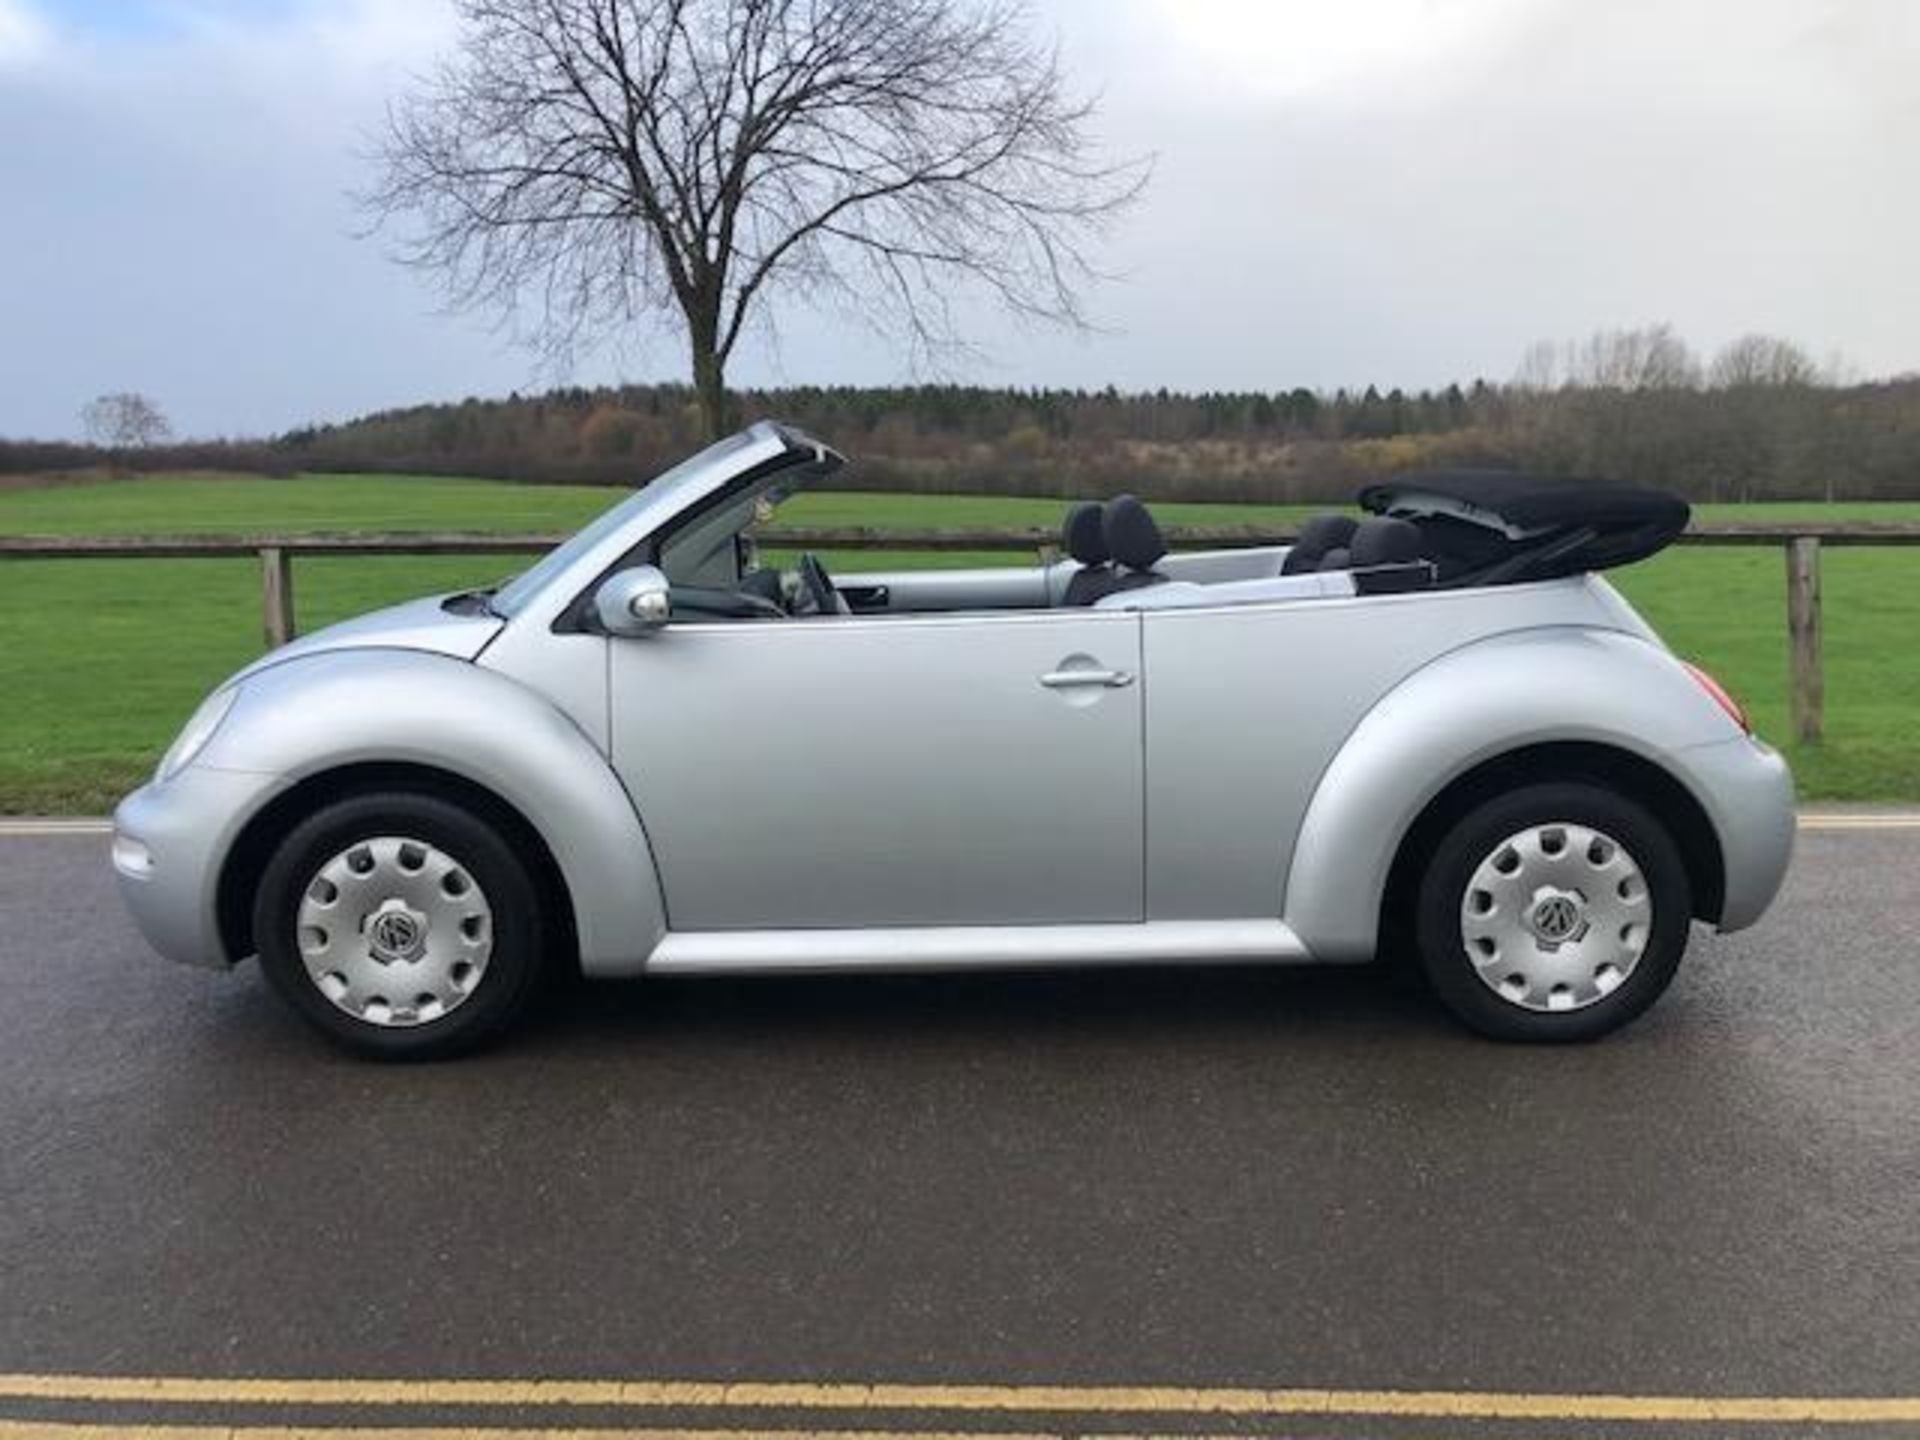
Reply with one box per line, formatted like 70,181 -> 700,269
253,793 -> 541,1060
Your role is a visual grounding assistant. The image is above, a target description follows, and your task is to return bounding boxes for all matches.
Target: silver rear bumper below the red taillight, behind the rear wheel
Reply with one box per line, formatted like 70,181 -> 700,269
1680,735 -> 1795,933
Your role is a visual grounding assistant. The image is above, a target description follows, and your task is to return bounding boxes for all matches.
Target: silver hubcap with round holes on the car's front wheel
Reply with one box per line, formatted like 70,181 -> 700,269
298,835 -> 493,1025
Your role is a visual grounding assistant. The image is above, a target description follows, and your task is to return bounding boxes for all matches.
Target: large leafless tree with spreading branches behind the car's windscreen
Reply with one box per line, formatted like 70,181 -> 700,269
365,0 -> 1146,434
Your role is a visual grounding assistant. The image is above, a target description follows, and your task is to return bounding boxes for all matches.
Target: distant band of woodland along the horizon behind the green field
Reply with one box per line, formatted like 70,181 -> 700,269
15,326 -> 1920,501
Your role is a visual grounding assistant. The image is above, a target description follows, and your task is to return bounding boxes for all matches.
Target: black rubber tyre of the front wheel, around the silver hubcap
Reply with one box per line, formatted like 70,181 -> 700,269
253,791 -> 545,1060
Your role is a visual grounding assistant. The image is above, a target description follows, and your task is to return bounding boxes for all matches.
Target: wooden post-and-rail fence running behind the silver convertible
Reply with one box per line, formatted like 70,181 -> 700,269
0,524 -> 1920,741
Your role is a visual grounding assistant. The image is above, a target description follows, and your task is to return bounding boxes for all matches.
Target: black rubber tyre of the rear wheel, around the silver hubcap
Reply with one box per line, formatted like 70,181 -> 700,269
1415,781 -> 1693,1043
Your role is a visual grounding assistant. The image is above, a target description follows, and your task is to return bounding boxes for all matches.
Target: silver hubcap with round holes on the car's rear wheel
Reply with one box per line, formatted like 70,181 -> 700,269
1459,824 -> 1653,1010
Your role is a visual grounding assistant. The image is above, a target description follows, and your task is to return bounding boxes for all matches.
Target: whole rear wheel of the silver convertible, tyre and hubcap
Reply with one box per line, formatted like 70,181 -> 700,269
1417,783 -> 1693,1041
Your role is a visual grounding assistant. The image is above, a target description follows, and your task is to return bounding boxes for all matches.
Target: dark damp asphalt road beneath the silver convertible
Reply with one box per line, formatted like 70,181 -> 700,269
0,829 -> 1920,1436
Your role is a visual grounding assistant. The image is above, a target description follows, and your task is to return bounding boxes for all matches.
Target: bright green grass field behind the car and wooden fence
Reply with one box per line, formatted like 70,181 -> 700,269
0,476 -> 1920,814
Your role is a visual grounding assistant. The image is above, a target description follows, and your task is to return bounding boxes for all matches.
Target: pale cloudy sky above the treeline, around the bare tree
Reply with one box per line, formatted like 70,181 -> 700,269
0,0 -> 1920,436
